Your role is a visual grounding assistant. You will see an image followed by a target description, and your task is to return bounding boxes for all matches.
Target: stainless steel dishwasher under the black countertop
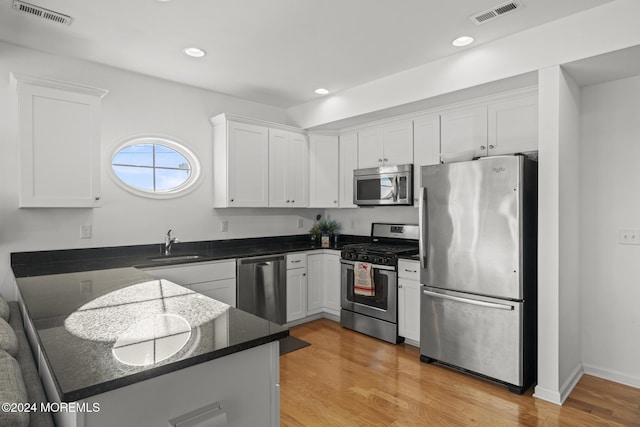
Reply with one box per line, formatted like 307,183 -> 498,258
236,255 -> 287,325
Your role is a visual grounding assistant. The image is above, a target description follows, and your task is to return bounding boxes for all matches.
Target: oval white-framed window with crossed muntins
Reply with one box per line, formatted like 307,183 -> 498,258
111,137 -> 200,197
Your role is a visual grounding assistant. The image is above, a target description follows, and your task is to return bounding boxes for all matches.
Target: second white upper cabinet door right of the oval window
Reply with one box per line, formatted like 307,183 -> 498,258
269,129 -> 291,207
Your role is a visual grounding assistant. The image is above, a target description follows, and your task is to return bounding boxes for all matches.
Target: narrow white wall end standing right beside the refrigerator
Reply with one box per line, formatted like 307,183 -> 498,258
535,66 -> 582,404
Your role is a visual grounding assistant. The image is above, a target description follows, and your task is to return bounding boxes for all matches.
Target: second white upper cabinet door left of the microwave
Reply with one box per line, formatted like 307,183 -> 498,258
309,135 -> 339,208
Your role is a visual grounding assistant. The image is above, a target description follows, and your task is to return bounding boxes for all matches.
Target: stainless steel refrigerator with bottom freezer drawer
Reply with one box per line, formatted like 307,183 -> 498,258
419,155 -> 537,393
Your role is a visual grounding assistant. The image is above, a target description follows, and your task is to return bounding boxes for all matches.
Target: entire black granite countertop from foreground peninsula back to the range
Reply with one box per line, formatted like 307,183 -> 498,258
11,235 -> 368,402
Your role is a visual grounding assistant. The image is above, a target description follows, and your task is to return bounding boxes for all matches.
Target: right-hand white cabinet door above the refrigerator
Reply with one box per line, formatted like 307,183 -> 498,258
489,94 -> 538,156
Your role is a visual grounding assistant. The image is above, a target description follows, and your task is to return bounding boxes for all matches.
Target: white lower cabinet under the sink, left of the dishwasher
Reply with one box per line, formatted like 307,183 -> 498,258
144,259 -> 236,307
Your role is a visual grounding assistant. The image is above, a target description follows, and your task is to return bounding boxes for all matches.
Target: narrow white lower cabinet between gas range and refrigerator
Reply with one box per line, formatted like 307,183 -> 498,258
398,260 -> 420,343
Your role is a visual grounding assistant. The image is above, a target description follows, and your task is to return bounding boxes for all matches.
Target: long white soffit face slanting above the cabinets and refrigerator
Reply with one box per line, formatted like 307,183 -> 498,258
287,0 -> 640,128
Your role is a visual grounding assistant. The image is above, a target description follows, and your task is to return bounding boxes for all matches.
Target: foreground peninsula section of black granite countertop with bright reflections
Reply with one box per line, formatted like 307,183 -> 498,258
17,267 -> 289,402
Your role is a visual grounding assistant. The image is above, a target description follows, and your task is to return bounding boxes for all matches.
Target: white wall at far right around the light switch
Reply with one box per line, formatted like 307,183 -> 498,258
580,76 -> 640,387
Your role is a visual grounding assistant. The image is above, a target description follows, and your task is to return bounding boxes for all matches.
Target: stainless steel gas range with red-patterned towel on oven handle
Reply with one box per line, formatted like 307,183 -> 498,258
340,223 -> 419,344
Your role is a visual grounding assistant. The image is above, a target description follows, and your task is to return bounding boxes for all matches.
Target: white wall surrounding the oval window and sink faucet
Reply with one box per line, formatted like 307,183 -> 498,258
0,43 -> 316,295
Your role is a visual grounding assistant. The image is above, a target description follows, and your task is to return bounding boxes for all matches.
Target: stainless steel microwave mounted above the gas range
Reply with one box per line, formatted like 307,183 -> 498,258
353,165 -> 413,206
